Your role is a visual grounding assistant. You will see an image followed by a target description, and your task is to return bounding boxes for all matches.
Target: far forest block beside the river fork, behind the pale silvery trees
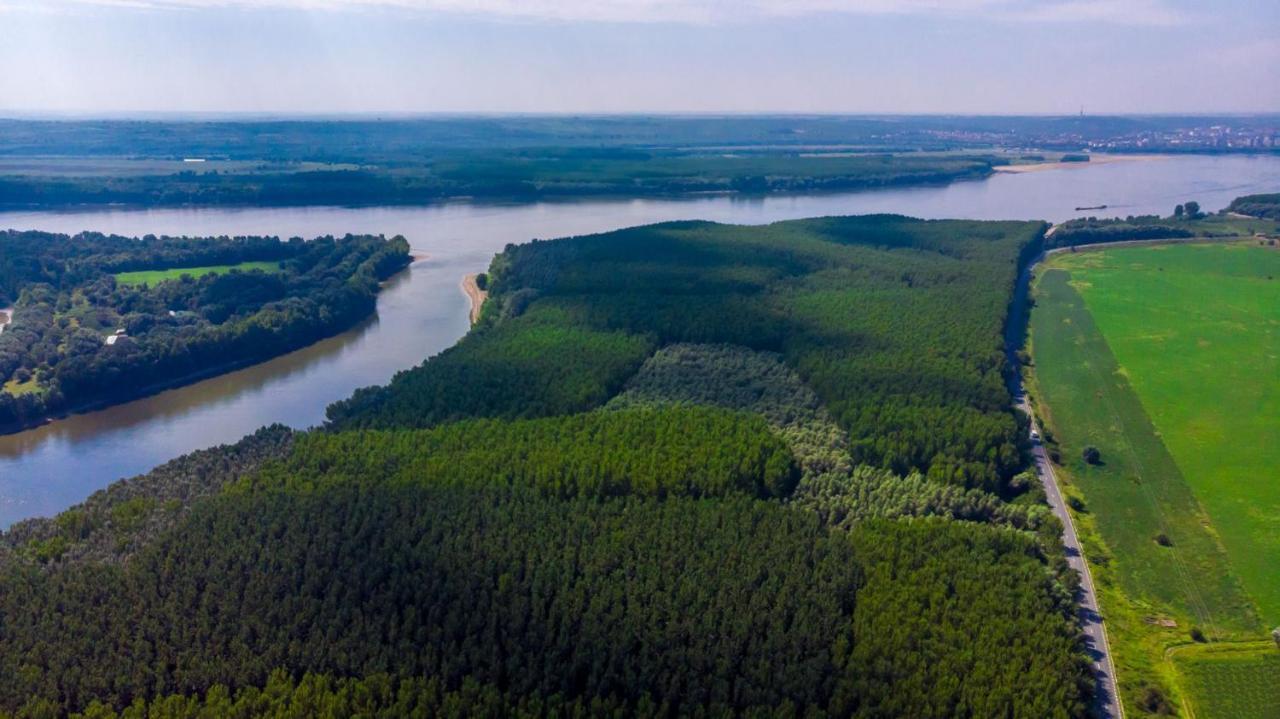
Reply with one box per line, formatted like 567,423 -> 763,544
330,216 -> 1043,491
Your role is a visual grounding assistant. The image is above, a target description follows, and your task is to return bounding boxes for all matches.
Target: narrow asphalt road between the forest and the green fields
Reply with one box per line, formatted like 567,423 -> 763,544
1006,248 -> 1124,719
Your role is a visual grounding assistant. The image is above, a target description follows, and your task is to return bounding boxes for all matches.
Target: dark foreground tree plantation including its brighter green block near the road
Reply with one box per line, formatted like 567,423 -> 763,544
0,486 -> 1083,716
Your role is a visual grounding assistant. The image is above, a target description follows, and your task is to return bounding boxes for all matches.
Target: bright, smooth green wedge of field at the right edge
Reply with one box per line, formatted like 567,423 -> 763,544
1062,243 -> 1280,621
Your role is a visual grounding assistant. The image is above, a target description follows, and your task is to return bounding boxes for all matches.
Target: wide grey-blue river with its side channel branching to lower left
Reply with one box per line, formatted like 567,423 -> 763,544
0,157 -> 1280,528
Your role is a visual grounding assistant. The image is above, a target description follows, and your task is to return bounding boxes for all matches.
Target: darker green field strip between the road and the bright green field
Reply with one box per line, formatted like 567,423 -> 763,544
1032,269 -> 1258,632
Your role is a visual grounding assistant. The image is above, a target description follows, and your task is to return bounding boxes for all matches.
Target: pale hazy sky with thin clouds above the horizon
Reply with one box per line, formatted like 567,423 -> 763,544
0,0 -> 1280,115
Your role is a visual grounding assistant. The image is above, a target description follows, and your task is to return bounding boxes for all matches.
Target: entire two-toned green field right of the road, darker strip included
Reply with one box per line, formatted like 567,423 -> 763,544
1032,243 -> 1280,704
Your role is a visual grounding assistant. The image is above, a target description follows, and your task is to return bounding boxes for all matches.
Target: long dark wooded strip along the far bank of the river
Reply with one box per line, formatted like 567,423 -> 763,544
0,148 -> 998,207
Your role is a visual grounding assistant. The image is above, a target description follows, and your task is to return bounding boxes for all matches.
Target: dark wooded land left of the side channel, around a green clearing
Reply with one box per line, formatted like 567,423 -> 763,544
0,230 -> 410,429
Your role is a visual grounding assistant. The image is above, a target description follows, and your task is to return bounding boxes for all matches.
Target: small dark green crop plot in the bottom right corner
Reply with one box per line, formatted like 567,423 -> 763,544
1172,642 -> 1280,719
